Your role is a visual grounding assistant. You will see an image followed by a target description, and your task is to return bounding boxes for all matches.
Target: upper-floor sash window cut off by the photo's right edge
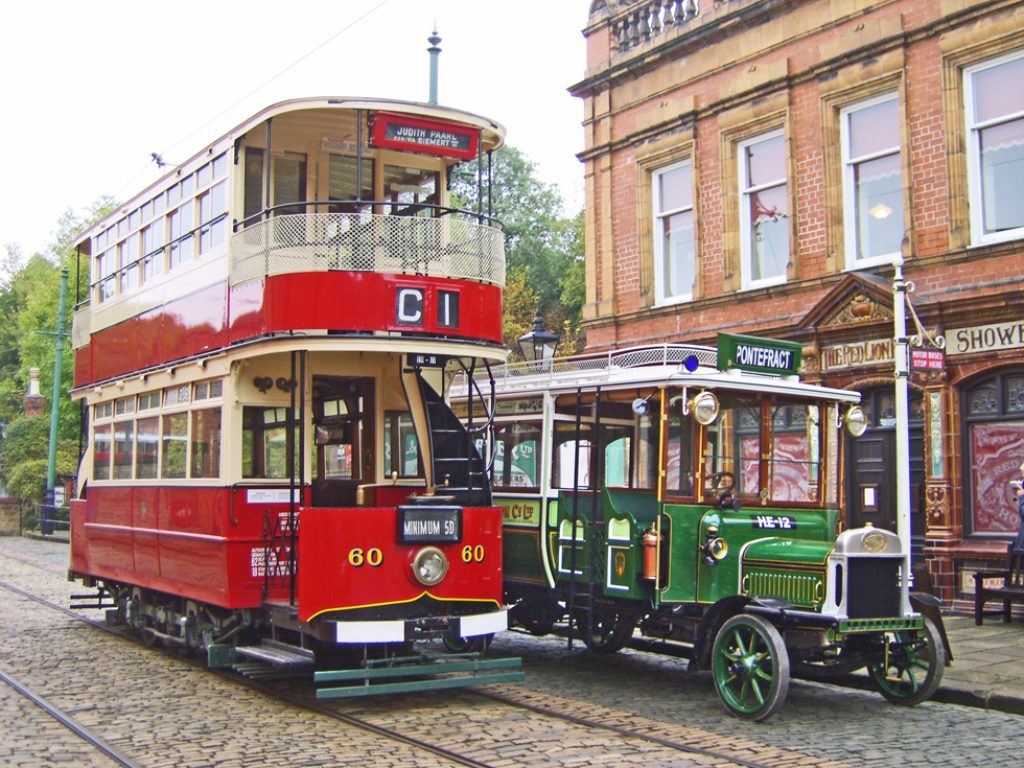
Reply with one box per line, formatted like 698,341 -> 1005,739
964,51 -> 1024,244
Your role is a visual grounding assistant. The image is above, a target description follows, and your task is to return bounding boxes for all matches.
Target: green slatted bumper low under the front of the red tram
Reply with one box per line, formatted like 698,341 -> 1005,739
313,653 -> 525,698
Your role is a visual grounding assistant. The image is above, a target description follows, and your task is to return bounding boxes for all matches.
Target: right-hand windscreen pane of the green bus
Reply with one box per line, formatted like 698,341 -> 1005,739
768,403 -> 821,502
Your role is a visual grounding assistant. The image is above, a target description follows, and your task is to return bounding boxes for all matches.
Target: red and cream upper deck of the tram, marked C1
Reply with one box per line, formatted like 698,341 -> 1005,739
73,98 -> 505,389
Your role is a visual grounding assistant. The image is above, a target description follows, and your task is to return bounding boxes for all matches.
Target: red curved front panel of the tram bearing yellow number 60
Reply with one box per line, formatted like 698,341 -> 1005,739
299,507 -> 502,621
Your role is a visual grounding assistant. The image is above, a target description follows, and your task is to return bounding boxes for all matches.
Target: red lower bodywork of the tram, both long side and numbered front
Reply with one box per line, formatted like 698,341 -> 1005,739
72,485 -> 502,621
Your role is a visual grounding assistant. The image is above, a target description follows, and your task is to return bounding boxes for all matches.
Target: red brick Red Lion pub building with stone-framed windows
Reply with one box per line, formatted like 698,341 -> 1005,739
571,0 -> 1024,599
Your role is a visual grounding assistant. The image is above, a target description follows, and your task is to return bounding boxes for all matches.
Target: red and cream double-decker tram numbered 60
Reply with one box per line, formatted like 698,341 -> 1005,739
71,98 -> 514,695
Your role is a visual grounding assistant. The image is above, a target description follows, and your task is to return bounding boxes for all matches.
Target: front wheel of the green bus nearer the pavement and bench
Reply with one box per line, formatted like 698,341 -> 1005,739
867,618 -> 946,707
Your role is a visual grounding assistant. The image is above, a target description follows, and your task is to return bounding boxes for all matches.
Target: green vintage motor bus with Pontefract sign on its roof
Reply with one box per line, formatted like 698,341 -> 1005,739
451,334 -> 947,720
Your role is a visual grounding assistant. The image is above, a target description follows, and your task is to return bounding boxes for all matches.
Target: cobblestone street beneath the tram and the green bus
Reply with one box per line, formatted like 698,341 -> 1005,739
0,539 -> 1022,768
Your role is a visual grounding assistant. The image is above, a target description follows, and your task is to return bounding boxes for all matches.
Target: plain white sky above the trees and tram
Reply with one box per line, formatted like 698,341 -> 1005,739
0,0 -> 591,257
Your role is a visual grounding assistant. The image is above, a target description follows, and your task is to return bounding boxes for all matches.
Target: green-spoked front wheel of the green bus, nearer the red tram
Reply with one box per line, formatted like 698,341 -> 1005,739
712,613 -> 790,722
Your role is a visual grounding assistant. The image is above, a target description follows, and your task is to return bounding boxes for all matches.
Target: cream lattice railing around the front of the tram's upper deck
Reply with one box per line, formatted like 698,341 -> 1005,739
230,206 -> 505,286
